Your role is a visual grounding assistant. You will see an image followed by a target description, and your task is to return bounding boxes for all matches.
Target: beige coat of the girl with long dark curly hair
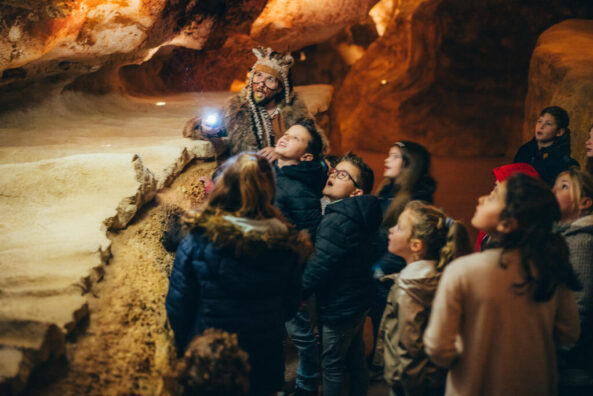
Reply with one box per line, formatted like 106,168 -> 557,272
424,249 -> 579,396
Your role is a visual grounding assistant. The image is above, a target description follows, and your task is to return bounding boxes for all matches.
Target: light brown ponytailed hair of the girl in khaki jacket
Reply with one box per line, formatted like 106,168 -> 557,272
404,201 -> 471,271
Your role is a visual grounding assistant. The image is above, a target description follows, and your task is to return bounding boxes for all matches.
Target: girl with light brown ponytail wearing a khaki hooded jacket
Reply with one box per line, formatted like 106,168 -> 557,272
378,201 -> 470,396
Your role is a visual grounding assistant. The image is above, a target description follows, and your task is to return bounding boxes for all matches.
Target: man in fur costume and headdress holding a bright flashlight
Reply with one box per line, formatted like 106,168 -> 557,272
183,47 -> 313,160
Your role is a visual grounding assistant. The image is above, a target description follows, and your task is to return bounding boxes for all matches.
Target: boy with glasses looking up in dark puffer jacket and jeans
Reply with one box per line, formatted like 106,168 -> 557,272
303,153 -> 381,396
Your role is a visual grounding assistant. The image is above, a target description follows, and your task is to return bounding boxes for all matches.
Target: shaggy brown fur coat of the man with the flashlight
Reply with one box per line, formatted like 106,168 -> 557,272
222,86 -> 313,155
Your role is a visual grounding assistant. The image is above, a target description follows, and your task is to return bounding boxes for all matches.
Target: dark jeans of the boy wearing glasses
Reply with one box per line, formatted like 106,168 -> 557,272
321,312 -> 369,396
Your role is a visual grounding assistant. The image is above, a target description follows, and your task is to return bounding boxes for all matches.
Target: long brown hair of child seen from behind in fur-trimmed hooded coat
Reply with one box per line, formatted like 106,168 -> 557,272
189,153 -> 282,224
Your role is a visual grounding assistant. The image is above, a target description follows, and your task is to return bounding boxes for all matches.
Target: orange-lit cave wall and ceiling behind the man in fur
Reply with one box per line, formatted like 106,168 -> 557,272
0,0 -> 593,156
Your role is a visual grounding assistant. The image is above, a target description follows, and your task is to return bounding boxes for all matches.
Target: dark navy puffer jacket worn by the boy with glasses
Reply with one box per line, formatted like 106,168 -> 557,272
303,195 -> 381,325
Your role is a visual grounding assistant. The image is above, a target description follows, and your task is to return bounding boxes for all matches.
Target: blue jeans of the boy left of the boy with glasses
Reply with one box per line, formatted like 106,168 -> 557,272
285,307 -> 319,392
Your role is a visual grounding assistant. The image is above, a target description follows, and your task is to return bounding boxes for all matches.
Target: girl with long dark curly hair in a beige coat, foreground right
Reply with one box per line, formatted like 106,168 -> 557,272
424,173 -> 579,396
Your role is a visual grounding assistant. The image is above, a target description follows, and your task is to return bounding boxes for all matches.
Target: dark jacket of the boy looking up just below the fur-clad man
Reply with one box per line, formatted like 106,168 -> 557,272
275,160 -> 327,240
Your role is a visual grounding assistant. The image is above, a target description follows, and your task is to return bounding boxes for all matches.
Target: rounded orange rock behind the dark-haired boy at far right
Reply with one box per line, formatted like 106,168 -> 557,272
523,19 -> 593,164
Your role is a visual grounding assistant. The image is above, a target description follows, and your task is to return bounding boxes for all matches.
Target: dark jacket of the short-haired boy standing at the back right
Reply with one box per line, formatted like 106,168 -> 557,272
513,135 -> 579,186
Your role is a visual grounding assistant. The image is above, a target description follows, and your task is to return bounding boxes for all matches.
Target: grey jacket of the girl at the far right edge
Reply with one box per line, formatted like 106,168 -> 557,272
560,214 -> 593,385
